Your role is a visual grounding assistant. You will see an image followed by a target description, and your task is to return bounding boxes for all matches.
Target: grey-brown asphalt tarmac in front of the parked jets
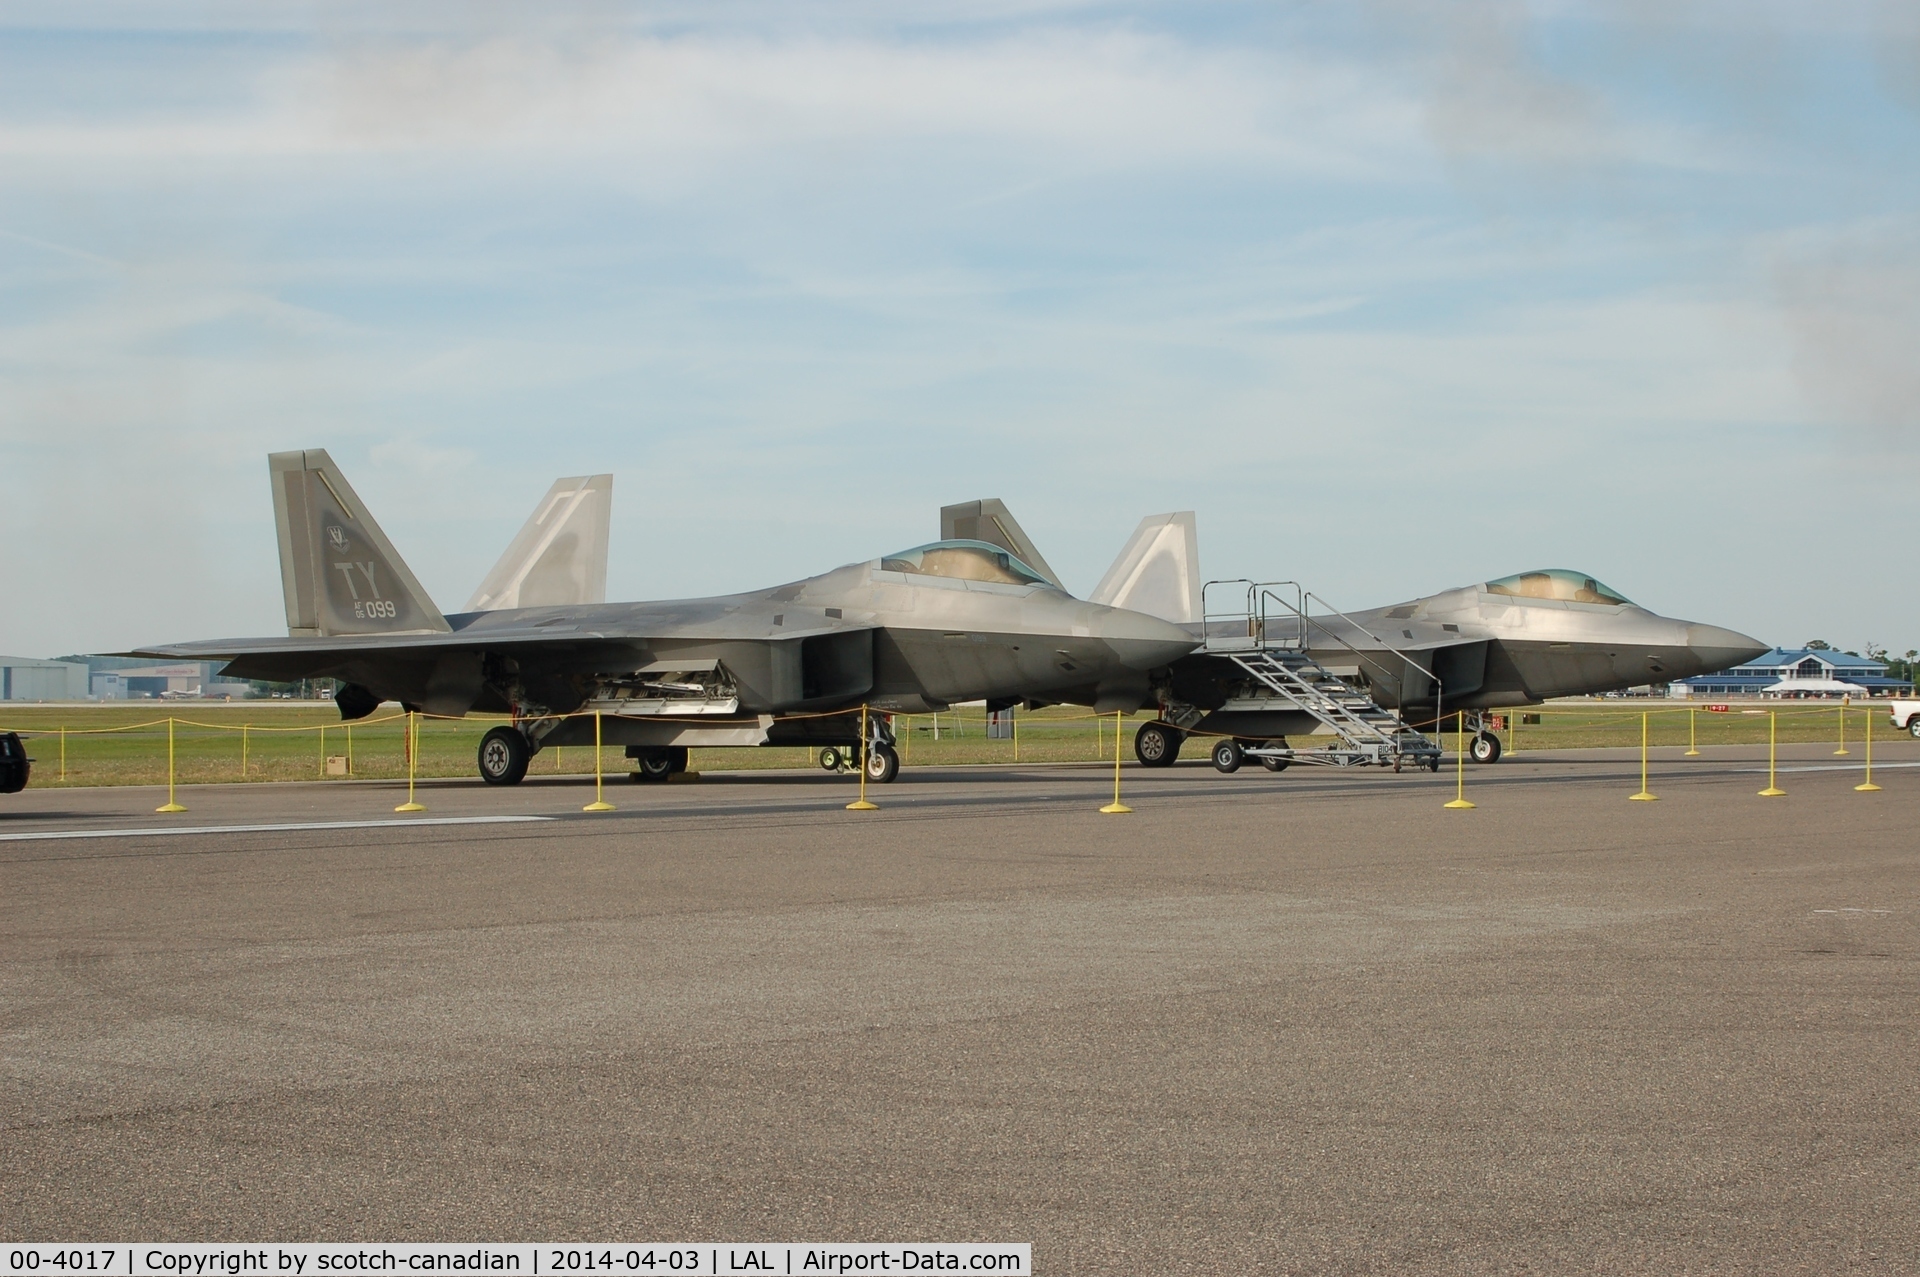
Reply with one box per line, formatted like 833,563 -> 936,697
0,741 -> 1920,1273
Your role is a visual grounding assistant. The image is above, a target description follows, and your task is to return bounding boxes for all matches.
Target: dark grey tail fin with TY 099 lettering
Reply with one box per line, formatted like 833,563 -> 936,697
267,447 -> 451,638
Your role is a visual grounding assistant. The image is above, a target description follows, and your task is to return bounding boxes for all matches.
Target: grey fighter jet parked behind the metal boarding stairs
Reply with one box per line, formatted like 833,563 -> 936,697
1089,511 -> 1768,766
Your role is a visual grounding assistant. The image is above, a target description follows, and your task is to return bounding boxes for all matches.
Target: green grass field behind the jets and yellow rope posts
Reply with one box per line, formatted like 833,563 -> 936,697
0,701 -> 1899,787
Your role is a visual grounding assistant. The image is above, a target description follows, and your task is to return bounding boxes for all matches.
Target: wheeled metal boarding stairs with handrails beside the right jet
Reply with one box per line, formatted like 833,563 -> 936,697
1202,580 -> 1440,772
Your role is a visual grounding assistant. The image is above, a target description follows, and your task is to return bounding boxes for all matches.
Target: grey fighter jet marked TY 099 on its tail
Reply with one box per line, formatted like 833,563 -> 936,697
140,449 -> 1196,785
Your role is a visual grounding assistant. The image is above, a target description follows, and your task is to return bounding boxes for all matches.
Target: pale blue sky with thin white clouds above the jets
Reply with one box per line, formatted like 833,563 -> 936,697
0,0 -> 1920,655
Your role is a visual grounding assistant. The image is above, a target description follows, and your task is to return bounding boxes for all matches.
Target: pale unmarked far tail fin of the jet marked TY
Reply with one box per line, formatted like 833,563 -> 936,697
463,474 -> 612,613
